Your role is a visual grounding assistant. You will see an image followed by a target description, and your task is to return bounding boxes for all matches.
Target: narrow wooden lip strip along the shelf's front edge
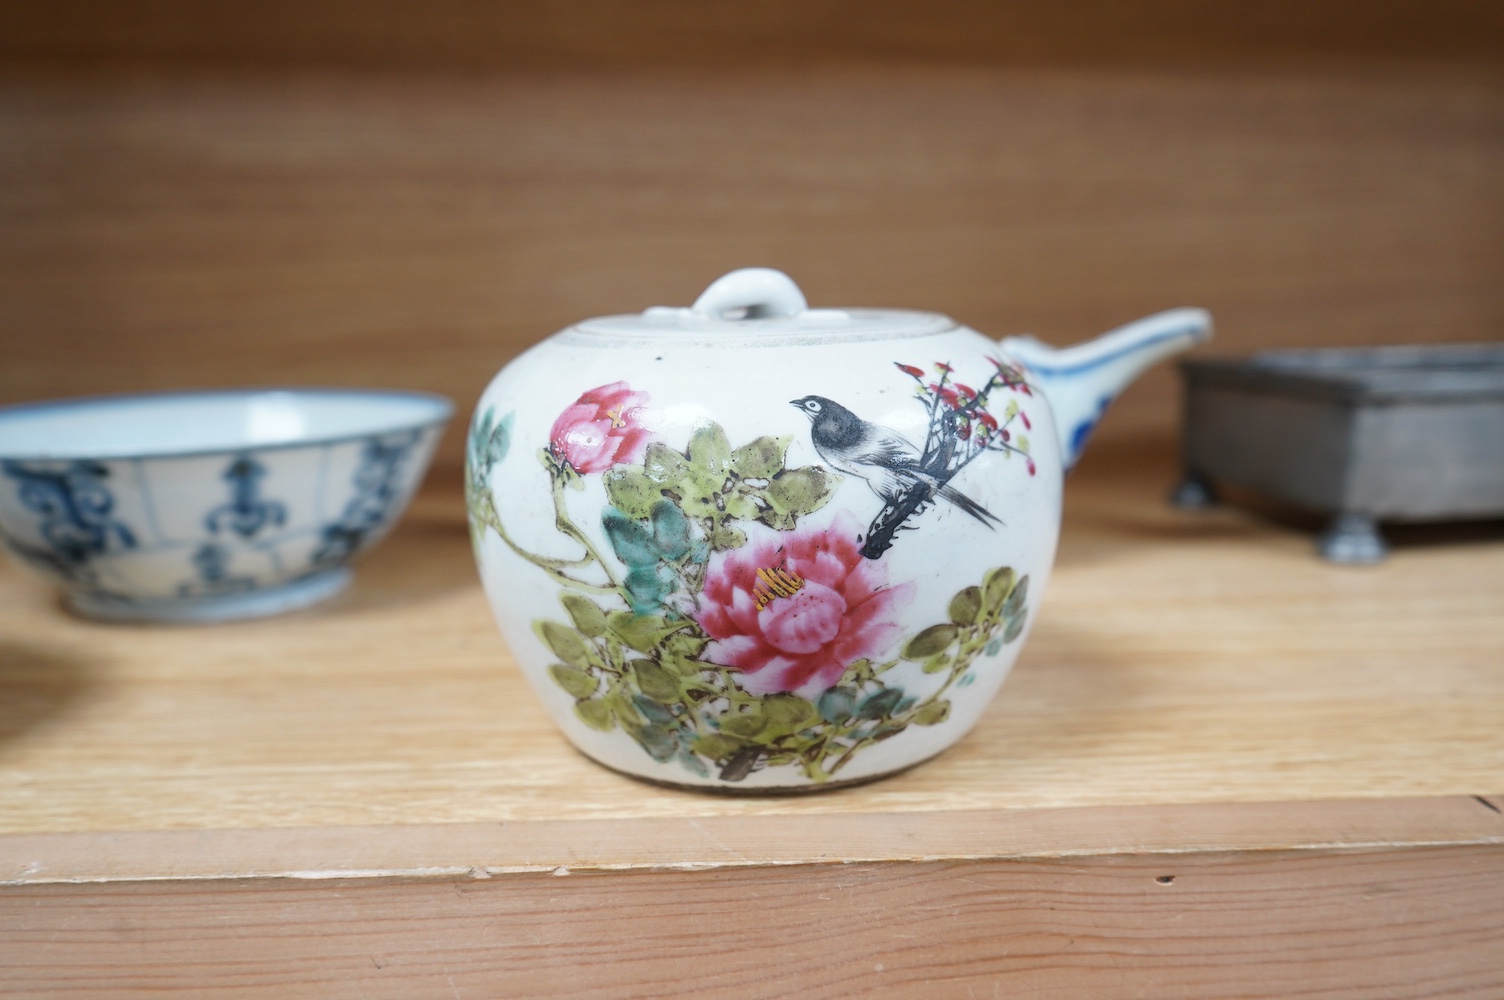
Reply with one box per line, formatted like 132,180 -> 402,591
0,795 -> 1504,892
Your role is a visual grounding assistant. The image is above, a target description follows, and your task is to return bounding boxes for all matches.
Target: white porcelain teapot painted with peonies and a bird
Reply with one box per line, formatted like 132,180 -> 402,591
466,268 -> 1211,791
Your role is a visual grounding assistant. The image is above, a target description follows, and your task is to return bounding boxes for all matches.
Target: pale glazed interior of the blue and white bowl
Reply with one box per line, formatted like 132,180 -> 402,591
0,389 -> 453,460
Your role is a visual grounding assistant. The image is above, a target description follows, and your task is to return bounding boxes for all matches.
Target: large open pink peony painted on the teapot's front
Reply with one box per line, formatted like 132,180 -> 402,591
695,511 -> 913,698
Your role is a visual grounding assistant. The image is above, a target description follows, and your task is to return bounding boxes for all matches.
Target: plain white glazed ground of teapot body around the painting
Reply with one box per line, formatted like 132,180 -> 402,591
468,314 -> 1063,791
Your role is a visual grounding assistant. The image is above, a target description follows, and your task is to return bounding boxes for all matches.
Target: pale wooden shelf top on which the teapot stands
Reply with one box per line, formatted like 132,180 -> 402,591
0,444 -> 1504,835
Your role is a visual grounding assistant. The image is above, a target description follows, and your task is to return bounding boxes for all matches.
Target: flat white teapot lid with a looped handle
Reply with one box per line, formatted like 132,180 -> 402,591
564,268 -> 957,344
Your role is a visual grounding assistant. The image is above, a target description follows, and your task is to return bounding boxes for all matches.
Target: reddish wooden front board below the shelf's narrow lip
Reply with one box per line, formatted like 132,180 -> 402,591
0,845 -> 1504,1000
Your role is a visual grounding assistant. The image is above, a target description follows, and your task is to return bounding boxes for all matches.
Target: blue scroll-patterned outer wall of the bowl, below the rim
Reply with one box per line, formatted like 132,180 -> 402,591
0,427 -> 442,613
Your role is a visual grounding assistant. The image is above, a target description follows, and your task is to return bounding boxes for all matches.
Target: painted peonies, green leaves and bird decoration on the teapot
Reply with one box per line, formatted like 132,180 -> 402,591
466,362 -> 1033,783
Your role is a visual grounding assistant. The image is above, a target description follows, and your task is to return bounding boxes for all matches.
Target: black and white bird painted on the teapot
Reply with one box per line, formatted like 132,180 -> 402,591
790,395 -> 1003,528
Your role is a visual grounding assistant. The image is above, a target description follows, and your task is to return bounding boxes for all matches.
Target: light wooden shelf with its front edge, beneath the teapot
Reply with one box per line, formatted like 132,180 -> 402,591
0,441 -> 1504,997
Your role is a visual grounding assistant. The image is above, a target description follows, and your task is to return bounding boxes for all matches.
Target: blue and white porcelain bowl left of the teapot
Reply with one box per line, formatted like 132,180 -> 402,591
0,389 -> 454,623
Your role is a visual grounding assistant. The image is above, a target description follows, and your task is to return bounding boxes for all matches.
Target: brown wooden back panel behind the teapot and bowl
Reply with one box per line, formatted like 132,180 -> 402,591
0,0 -> 1504,475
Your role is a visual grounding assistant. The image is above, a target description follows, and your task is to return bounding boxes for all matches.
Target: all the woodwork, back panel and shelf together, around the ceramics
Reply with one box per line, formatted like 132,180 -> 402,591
0,7 -> 1504,1000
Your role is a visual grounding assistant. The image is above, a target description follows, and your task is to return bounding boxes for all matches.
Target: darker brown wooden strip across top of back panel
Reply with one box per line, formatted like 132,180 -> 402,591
0,0 -> 1504,71
